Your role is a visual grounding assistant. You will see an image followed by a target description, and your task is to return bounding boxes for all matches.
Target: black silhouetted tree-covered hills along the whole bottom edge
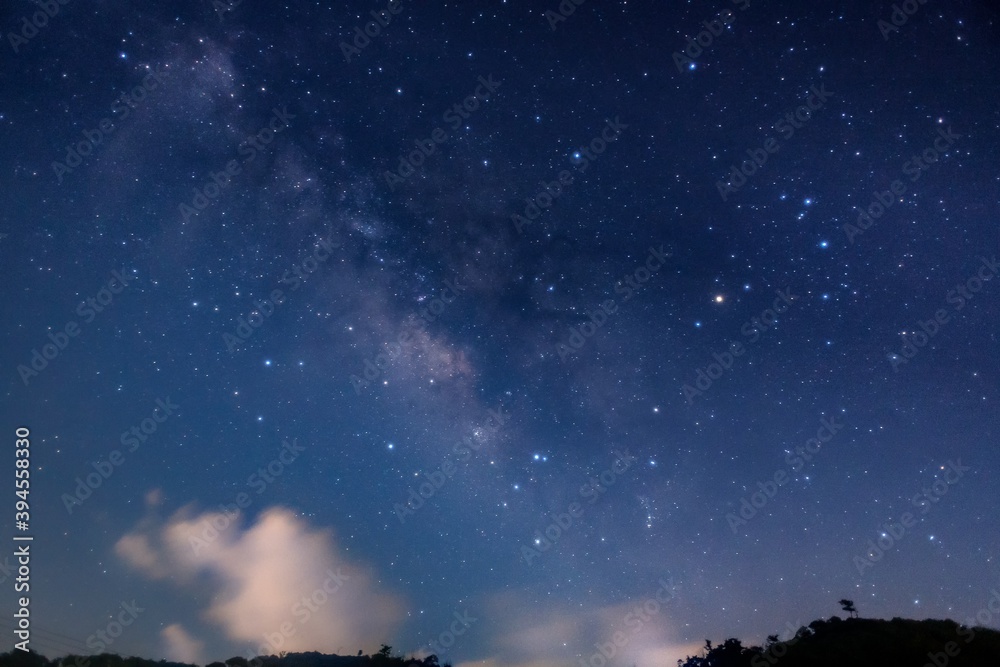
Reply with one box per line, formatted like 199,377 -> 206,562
0,616 -> 1000,667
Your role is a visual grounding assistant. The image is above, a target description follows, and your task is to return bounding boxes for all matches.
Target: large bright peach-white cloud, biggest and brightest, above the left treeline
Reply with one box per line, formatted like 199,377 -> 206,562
115,507 -> 403,654
